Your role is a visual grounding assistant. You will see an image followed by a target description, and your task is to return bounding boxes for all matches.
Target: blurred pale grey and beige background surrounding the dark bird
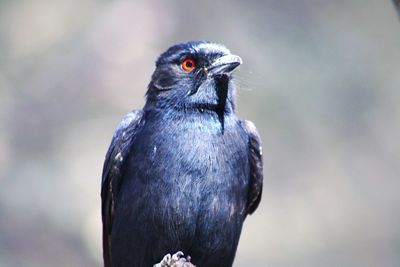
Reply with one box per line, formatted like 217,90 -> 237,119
0,0 -> 400,267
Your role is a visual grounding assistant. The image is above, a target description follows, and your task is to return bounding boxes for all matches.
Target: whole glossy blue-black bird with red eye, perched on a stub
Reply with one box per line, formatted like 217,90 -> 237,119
101,41 -> 263,267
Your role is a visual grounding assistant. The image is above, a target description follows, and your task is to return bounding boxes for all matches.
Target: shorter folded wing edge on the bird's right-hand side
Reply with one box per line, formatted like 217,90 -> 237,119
243,120 -> 263,214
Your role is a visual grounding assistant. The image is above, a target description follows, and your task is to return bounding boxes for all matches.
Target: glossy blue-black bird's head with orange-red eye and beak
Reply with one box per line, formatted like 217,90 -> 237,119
145,41 -> 242,116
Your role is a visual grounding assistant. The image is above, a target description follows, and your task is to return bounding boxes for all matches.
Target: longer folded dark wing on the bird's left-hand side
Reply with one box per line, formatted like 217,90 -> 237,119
101,110 -> 143,267
